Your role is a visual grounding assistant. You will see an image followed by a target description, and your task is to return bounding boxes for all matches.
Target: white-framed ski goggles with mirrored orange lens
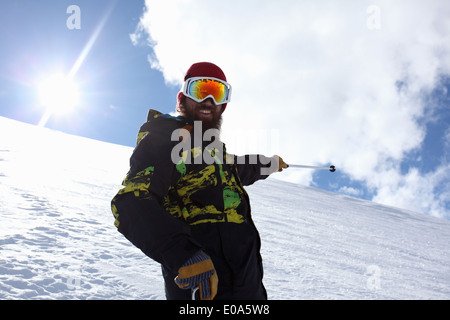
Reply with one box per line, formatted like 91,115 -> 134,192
182,77 -> 231,105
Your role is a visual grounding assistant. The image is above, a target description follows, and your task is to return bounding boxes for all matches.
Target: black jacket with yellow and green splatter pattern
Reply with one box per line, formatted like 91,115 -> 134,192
111,110 -> 270,299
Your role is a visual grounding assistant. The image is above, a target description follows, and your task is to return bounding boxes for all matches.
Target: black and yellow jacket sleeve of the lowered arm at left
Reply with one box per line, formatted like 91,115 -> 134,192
111,121 -> 201,273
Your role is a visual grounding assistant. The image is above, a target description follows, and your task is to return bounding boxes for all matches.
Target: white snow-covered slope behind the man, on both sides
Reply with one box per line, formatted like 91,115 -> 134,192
0,117 -> 450,300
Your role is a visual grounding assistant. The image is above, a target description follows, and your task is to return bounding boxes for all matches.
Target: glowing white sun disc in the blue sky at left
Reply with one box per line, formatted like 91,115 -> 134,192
38,74 -> 79,114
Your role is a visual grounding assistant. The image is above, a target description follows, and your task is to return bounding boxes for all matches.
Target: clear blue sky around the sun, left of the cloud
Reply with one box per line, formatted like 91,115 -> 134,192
0,0 -> 174,146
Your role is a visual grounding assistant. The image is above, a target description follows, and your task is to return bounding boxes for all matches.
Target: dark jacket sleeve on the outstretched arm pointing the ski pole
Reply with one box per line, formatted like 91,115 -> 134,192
234,154 -> 278,186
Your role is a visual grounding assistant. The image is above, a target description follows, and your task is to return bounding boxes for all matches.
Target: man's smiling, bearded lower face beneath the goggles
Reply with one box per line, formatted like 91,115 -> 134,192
179,97 -> 223,131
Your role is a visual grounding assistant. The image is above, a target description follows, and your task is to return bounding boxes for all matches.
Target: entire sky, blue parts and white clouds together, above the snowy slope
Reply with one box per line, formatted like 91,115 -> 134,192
0,0 -> 450,218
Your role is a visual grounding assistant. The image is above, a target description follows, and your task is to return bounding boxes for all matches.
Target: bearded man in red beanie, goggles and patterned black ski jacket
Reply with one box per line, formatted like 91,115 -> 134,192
111,62 -> 287,300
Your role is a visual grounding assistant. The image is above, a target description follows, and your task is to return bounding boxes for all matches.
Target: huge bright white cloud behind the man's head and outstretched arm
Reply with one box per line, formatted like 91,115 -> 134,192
132,0 -> 450,218
